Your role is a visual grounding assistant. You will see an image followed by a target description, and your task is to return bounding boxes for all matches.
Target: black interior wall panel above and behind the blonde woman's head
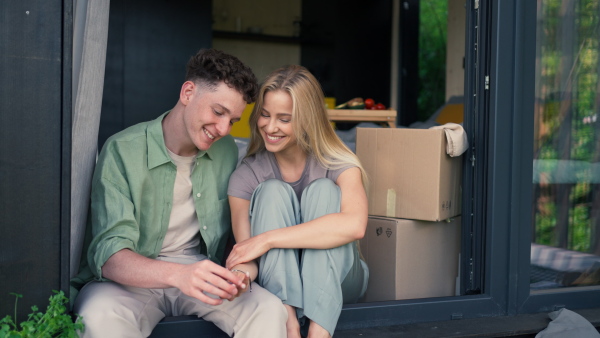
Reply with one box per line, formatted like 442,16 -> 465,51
301,0 -> 392,111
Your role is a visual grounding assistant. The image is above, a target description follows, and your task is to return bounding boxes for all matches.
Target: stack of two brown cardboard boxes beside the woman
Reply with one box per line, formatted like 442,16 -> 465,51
356,128 -> 462,302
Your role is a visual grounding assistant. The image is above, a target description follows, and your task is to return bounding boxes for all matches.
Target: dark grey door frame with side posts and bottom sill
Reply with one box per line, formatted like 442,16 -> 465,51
45,0 -> 600,329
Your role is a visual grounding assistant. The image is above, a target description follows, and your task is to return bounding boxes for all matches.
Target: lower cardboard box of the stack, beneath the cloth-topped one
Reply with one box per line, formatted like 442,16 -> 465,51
360,216 -> 461,302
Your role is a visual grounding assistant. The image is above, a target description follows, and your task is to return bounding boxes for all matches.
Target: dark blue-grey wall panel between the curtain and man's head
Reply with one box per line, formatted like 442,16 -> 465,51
99,0 -> 212,147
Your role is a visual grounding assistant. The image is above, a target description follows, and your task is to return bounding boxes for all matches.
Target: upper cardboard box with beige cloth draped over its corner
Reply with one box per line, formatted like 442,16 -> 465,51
356,128 -> 462,221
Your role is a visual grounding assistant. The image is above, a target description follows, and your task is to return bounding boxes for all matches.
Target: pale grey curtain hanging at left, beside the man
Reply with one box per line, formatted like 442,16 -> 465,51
70,0 -> 110,277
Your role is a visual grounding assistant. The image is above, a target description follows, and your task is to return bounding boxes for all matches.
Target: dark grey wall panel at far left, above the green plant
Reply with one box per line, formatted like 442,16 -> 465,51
0,0 -> 63,320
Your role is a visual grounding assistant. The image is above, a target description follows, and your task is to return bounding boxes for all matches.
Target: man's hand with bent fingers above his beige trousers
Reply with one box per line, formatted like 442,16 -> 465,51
173,259 -> 249,305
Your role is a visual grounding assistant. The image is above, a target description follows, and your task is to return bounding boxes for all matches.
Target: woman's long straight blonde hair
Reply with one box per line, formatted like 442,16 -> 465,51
246,65 -> 368,189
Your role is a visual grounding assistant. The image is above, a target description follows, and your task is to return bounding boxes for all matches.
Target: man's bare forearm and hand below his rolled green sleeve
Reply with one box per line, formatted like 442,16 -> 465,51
102,249 -> 246,305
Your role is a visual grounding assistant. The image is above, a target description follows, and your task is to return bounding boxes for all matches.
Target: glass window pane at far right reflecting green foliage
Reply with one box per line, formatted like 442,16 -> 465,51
530,0 -> 600,290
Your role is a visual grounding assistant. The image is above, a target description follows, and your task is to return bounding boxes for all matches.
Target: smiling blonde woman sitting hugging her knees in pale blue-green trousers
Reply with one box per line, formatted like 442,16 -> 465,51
227,66 -> 368,337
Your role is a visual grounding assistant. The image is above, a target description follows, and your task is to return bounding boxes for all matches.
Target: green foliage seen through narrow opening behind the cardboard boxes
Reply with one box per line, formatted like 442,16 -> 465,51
417,0 -> 448,121
